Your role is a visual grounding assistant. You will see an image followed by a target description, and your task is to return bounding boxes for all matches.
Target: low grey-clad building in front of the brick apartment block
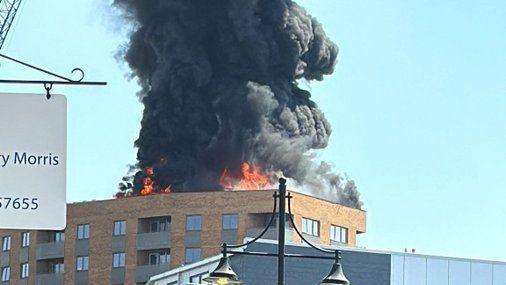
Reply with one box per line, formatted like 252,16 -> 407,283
148,240 -> 506,285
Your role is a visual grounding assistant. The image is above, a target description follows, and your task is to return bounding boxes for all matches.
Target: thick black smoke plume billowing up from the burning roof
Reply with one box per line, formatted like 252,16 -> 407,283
113,0 -> 362,208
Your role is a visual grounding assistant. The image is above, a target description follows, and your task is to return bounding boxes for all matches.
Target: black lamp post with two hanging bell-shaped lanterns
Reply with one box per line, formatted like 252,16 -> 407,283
204,178 -> 350,285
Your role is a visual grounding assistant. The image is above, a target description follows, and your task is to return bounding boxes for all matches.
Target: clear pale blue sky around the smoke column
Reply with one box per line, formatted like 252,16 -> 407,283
0,0 -> 506,260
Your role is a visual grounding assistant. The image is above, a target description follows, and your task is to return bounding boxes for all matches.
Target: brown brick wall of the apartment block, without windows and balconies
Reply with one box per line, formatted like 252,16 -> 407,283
0,191 -> 366,284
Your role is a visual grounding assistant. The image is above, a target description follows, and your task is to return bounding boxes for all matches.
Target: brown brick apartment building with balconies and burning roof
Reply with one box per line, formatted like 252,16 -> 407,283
0,190 -> 366,285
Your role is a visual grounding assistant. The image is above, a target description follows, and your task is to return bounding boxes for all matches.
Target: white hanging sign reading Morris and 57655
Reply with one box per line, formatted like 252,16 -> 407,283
0,93 -> 67,230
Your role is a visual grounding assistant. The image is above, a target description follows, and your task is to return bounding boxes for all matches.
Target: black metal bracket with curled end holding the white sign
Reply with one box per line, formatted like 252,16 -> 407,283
0,53 -> 107,99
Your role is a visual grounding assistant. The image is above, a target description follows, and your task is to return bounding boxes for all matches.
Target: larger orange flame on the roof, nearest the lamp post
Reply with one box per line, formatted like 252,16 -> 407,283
220,162 -> 272,190
